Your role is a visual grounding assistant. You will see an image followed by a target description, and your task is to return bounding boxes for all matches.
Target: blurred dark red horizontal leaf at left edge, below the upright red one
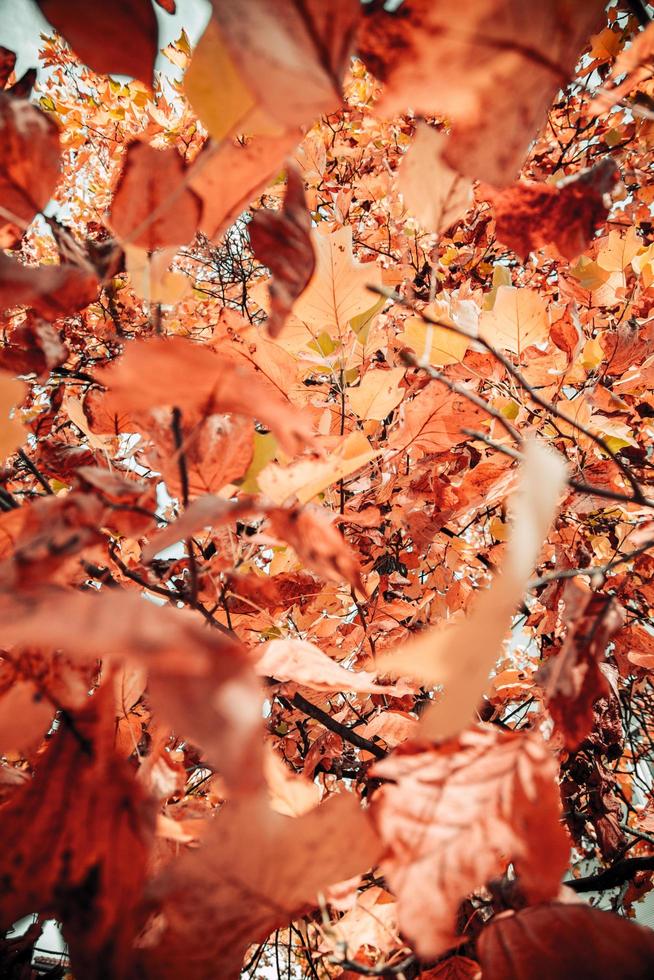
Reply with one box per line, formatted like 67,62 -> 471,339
0,252 -> 99,320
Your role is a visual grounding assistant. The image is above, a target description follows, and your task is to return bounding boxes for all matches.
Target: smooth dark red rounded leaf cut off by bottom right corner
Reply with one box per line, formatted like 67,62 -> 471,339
478,904 -> 654,980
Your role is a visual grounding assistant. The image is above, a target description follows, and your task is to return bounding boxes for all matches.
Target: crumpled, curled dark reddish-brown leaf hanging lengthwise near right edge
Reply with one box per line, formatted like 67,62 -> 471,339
536,583 -> 624,750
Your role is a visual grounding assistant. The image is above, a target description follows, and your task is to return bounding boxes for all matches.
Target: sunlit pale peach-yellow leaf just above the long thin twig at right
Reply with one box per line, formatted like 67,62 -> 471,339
479,286 -> 550,356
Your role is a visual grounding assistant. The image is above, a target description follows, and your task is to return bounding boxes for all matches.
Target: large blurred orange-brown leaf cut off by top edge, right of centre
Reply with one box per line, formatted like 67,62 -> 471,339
358,0 -> 604,187
